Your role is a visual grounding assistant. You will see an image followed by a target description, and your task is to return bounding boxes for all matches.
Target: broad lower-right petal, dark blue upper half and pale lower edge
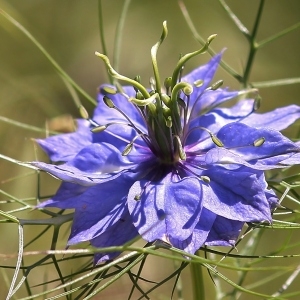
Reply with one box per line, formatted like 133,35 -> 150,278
202,166 -> 272,222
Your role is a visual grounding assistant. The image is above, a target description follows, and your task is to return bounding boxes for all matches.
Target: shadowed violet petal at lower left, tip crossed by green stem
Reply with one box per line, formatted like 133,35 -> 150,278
91,210 -> 138,265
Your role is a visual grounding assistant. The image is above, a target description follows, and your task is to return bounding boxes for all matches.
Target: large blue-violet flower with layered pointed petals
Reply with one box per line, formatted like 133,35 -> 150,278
33,54 -> 300,263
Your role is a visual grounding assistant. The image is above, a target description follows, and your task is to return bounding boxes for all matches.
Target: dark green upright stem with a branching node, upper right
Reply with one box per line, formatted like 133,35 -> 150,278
242,0 -> 265,87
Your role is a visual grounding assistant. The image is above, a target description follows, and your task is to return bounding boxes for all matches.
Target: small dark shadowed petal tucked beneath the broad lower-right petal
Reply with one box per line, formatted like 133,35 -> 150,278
205,216 -> 244,246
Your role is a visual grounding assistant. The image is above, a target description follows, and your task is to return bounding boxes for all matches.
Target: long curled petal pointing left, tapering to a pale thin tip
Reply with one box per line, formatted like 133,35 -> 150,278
31,143 -> 129,186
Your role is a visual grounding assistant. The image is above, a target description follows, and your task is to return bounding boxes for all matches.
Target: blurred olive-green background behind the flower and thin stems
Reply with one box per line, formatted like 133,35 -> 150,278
0,0 -> 300,299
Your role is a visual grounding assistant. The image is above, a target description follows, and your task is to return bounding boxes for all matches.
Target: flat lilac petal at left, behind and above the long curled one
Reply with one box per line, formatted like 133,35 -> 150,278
36,120 -> 92,162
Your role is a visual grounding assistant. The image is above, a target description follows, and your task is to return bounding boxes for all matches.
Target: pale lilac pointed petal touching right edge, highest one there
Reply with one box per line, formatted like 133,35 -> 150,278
242,105 -> 300,131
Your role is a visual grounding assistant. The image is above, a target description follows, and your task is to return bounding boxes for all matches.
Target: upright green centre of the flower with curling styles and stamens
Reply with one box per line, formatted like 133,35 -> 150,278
96,22 -> 216,165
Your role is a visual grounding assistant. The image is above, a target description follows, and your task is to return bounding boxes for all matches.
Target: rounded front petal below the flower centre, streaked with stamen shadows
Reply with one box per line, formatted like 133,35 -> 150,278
128,174 -> 202,241
